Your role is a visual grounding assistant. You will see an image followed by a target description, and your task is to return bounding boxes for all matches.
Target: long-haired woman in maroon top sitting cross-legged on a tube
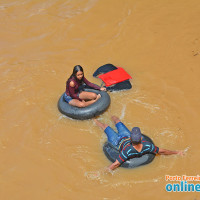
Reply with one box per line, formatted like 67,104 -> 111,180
64,65 -> 106,108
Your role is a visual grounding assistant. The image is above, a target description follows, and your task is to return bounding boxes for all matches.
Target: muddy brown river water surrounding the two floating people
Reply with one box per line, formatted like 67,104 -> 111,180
0,0 -> 200,200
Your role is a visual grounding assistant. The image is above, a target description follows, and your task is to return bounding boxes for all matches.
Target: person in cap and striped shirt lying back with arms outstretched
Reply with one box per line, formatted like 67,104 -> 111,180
94,116 -> 183,171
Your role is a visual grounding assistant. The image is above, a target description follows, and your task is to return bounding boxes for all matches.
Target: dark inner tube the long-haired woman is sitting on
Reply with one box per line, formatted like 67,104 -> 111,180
58,88 -> 110,120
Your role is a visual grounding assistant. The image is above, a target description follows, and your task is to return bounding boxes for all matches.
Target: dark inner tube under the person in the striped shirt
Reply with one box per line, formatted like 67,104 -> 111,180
103,135 -> 155,168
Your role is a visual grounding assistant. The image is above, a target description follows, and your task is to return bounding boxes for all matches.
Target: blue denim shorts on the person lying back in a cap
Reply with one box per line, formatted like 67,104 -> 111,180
104,122 -> 131,147
